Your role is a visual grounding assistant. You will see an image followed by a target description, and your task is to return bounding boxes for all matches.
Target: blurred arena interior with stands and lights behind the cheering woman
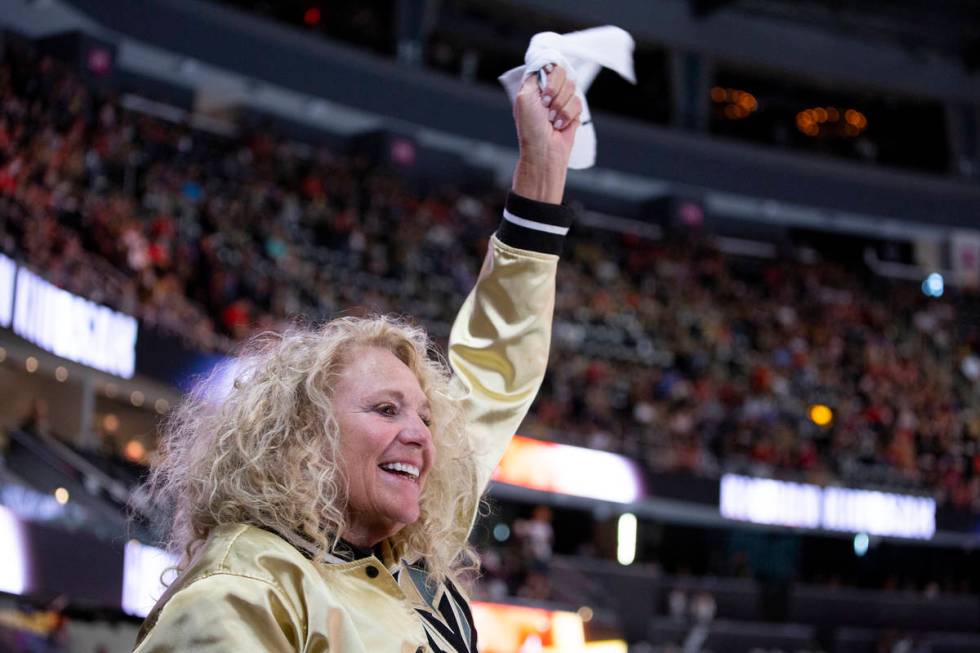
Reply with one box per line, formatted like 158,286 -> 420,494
0,0 -> 980,653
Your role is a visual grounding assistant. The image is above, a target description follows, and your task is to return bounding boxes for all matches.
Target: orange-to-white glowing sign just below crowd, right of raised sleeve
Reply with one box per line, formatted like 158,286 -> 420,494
493,435 -> 643,503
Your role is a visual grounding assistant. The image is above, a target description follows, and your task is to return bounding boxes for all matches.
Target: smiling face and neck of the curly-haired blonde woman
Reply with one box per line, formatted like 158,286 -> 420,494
333,346 -> 435,547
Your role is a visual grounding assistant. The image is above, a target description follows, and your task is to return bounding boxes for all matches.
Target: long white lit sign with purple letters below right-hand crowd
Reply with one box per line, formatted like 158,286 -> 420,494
721,474 -> 936,540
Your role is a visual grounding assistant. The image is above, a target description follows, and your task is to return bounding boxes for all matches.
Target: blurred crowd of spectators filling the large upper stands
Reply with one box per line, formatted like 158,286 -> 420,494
0,40 -> 980,511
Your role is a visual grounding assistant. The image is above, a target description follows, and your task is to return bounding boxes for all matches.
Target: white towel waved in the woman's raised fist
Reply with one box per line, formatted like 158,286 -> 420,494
499,25 -> 636,170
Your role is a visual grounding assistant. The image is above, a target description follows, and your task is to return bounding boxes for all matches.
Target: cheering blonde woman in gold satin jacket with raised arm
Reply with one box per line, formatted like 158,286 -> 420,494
136,67 -> 581,653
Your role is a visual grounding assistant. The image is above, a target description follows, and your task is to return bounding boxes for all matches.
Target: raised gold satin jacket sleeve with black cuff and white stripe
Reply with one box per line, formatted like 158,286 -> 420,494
449,193 -> 573,491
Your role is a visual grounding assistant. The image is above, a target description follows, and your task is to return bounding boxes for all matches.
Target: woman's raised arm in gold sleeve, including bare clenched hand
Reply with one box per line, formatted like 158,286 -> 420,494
449,68 -> 581,489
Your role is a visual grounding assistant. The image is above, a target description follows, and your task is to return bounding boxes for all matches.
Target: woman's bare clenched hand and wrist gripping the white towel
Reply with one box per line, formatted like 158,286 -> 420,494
513,64 -> 582,204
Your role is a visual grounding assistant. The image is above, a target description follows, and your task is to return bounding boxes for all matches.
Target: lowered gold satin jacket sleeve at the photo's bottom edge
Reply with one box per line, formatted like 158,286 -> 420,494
133,574 -> 303,653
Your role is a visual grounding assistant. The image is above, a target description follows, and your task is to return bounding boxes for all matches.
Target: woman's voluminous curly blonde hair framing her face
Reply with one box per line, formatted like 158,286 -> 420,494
144,317 -> 480,582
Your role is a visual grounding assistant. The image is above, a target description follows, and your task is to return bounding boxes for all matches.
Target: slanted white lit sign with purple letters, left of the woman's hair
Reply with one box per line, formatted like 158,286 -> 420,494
13,268 -> 137,379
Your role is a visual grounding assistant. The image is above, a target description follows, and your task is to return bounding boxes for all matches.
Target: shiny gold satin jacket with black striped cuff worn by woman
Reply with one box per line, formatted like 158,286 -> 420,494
135,194 -> 571,653
